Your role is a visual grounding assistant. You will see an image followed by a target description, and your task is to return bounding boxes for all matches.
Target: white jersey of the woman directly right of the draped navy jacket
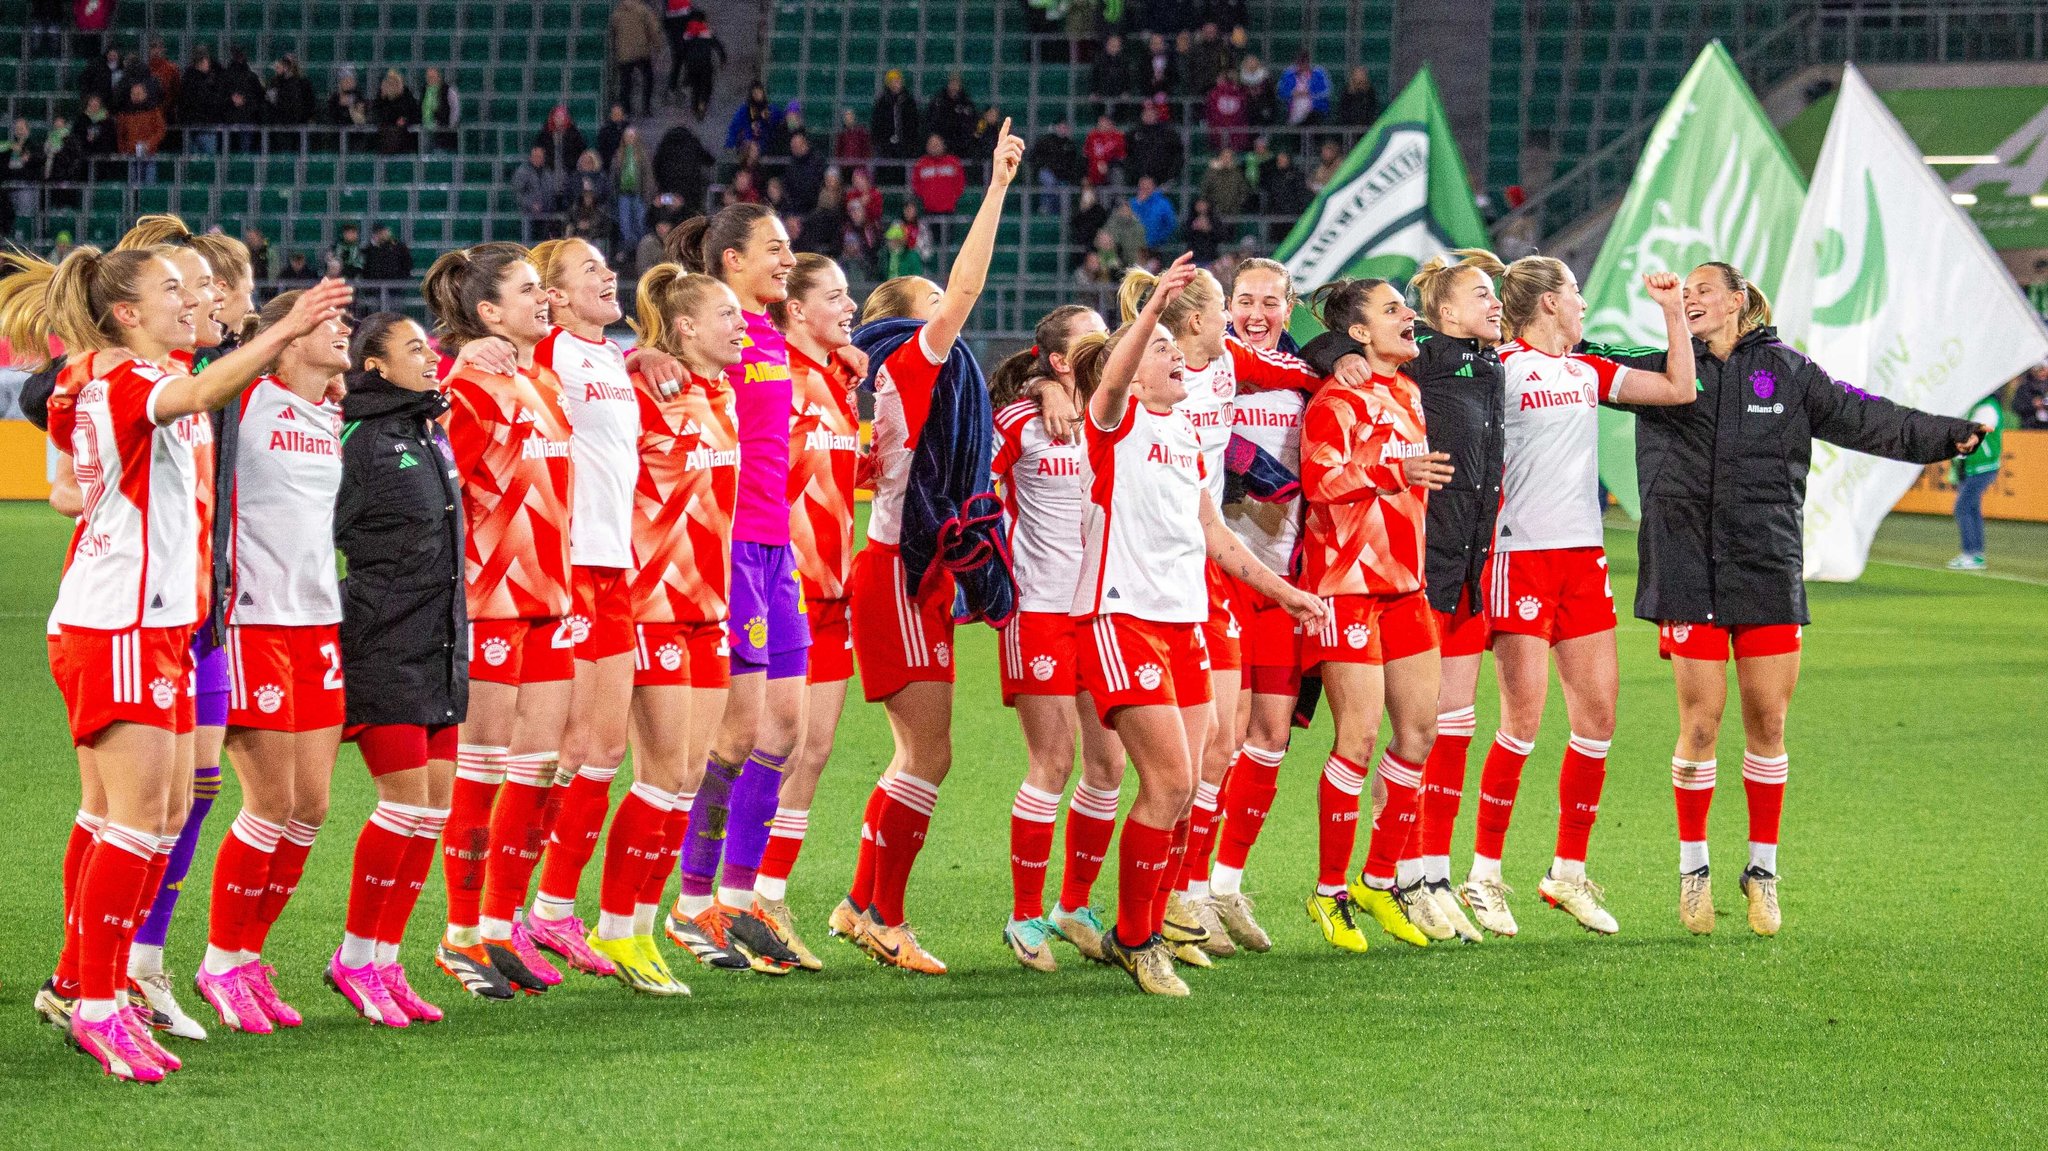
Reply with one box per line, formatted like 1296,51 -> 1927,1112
993,399 -> 1087,612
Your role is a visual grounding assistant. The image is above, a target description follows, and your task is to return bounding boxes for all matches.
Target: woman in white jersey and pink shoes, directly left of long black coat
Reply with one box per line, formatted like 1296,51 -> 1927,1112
195,293 -> 354,1034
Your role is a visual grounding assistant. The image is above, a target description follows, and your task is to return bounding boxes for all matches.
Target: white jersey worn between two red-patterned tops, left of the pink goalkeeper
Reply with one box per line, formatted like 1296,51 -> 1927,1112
532,328 -> 639,567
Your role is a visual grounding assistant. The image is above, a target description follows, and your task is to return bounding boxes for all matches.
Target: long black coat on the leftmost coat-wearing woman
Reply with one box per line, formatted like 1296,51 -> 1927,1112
334,373 -> 469,727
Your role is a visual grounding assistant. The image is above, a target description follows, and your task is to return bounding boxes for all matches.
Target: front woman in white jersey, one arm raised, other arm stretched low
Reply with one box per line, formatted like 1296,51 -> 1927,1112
1069,256 -> 1323,995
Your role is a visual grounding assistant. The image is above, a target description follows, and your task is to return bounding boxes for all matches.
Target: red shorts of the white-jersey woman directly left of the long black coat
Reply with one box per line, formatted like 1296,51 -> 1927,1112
227,623 -> 348,731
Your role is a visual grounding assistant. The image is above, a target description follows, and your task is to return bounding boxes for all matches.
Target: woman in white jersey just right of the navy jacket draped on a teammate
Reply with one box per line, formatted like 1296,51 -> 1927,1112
989,303 -> 1124,971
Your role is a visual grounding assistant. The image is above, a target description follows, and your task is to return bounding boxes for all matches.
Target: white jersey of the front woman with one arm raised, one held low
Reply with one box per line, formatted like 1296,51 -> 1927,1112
1069,399 -> 1208,623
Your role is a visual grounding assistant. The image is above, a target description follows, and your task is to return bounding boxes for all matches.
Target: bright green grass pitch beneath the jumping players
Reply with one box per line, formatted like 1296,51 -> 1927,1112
0,504 -> 2048,1149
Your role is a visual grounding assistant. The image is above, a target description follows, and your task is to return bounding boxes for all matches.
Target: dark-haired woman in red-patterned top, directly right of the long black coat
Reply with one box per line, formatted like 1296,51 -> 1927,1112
420,244 -> 575,995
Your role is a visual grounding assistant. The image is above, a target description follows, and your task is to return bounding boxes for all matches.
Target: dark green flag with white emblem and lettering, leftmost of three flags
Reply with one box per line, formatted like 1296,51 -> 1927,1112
1274,68 -> 1487,340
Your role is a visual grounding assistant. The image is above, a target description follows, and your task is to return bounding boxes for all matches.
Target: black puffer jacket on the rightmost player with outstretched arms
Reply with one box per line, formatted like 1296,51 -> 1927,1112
1593,328 -> 1974,627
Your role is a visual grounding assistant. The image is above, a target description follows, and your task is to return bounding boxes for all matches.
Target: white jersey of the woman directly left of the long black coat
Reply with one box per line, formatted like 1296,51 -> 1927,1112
227,377 -> 342,627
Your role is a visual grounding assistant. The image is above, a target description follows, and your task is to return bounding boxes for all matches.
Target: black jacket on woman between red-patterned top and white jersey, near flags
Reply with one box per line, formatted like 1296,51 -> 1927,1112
1300,324 -> 1507,612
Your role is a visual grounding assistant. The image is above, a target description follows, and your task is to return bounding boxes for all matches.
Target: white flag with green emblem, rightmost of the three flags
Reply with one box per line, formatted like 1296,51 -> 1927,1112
1776,66 -> 2048,580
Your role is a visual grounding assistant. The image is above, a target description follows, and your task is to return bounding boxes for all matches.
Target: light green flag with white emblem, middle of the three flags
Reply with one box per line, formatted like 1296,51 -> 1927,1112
1585,41 -> 1806,516
